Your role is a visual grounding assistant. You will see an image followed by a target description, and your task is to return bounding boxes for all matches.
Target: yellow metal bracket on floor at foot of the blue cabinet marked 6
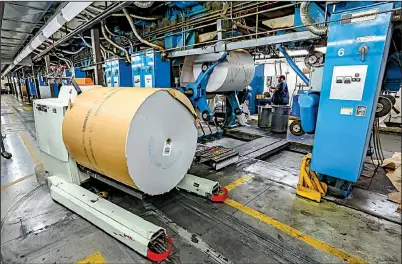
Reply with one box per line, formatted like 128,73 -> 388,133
296,153 -> 328,202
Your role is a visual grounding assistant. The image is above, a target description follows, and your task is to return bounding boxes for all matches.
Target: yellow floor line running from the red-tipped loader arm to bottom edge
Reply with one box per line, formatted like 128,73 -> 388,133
225,182 -> 367,263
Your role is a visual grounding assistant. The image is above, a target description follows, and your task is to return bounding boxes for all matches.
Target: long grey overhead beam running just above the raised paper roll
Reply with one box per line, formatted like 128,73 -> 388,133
168,31 -> 320,58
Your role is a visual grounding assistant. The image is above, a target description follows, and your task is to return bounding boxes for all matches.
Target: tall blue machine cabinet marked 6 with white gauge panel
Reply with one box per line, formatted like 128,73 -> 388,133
311,3 -> 393,182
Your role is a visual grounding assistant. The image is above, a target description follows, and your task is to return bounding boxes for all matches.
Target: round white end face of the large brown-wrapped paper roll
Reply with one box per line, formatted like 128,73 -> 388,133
126,92 -> 197,195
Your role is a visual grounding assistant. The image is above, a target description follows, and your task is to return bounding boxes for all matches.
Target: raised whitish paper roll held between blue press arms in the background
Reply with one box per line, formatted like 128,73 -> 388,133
180,51 -> 255,93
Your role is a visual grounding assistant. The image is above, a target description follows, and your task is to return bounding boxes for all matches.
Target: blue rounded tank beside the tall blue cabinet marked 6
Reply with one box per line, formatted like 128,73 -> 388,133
298,92 -> 320,134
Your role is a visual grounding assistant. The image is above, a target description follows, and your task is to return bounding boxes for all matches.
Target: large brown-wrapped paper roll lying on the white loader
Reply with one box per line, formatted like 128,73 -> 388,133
62,88 -> 197,195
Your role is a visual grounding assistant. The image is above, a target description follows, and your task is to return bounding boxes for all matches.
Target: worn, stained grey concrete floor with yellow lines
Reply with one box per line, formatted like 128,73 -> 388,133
1,95 -> 402,263
